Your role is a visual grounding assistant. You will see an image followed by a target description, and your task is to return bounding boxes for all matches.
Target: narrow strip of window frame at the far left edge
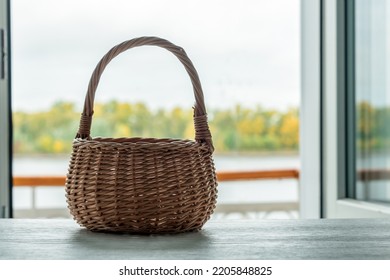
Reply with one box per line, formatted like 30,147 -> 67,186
0,0 -> 12,218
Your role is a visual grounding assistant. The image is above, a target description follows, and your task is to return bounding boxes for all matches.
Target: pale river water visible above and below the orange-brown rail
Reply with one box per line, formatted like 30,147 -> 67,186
13,155 -> 299,209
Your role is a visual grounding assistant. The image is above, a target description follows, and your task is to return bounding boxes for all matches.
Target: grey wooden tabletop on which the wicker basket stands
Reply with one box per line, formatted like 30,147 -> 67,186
0,219 -> 390,260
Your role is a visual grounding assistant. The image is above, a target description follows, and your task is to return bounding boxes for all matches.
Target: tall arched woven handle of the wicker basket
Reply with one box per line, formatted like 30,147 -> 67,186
76,37 -> 214,152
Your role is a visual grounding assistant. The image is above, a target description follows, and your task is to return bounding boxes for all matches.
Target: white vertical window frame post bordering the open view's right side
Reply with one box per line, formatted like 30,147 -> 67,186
299,0 -> 322,219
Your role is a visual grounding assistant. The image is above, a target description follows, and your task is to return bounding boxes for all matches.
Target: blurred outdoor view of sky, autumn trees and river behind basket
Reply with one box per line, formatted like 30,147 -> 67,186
11,0 -> 300,218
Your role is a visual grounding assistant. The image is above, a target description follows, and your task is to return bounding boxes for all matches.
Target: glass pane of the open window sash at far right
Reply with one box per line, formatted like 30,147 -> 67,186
355,0 -> 390,203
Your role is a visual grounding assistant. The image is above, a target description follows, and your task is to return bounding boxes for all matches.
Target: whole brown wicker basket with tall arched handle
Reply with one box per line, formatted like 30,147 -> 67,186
66,37 -> 217,233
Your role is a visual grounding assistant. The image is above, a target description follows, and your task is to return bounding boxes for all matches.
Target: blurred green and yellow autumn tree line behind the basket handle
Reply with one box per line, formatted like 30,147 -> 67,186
13,101 -> 299,153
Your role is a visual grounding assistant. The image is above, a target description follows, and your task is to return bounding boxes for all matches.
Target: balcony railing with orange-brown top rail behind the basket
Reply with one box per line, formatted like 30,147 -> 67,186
13,169 -> 299,218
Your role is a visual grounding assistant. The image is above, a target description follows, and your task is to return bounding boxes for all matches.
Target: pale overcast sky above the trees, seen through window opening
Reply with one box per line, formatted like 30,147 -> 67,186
12,0 -> 300,110
